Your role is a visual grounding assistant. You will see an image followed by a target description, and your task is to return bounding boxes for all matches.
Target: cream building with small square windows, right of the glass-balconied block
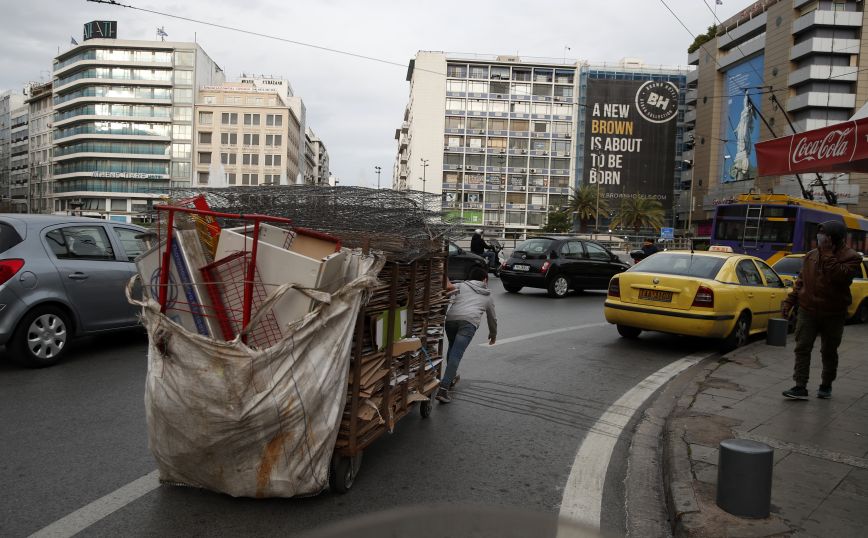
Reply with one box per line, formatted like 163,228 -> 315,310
195,81 -> 301,187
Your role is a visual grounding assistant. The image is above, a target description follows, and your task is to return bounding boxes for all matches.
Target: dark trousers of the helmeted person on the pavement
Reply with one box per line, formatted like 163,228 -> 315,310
793,308 -> 845,387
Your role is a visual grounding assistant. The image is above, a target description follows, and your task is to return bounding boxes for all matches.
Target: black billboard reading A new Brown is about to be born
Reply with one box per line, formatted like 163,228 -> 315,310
582,79 -> 678,204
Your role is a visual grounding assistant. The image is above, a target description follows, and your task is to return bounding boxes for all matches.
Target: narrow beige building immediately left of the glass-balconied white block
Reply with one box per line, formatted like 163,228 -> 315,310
27,82 -> 53,213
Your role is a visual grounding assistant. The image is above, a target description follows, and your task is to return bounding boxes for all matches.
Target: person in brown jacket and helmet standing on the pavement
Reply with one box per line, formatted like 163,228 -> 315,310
781,221 -> 862,400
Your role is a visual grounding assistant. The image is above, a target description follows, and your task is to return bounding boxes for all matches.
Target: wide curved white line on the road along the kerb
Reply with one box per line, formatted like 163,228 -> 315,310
560,353 -> 714,529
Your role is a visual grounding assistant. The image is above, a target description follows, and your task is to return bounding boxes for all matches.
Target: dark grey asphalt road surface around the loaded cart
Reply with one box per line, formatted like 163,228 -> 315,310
0,279 -> 712,536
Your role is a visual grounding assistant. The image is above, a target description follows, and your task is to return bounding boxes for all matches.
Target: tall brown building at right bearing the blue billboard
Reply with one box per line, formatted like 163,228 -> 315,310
678,0 -> 868,228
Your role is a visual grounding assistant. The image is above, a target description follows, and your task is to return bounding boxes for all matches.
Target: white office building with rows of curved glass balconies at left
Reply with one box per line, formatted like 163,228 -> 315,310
52,36 -> 224,221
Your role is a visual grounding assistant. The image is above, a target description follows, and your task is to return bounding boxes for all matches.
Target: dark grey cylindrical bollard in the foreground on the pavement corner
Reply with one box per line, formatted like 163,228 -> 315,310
717,439 -> 775,518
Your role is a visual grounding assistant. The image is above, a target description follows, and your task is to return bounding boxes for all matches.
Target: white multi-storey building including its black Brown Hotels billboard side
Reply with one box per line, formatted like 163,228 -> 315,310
393,51 -> 687,237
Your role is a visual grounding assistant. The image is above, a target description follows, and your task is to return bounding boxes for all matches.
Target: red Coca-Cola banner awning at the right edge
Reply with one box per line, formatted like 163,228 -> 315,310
756,118 -> 868,176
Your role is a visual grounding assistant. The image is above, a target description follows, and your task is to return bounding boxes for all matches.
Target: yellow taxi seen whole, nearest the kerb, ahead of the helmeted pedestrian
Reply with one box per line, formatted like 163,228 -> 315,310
604,247 -> 790,351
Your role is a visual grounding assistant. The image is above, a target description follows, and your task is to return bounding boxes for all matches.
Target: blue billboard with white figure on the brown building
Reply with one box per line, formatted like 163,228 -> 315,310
719,55 -> 764,183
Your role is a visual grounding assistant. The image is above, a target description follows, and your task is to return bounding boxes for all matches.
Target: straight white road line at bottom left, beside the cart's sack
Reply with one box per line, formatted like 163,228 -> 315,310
30,471 -> 160,538
